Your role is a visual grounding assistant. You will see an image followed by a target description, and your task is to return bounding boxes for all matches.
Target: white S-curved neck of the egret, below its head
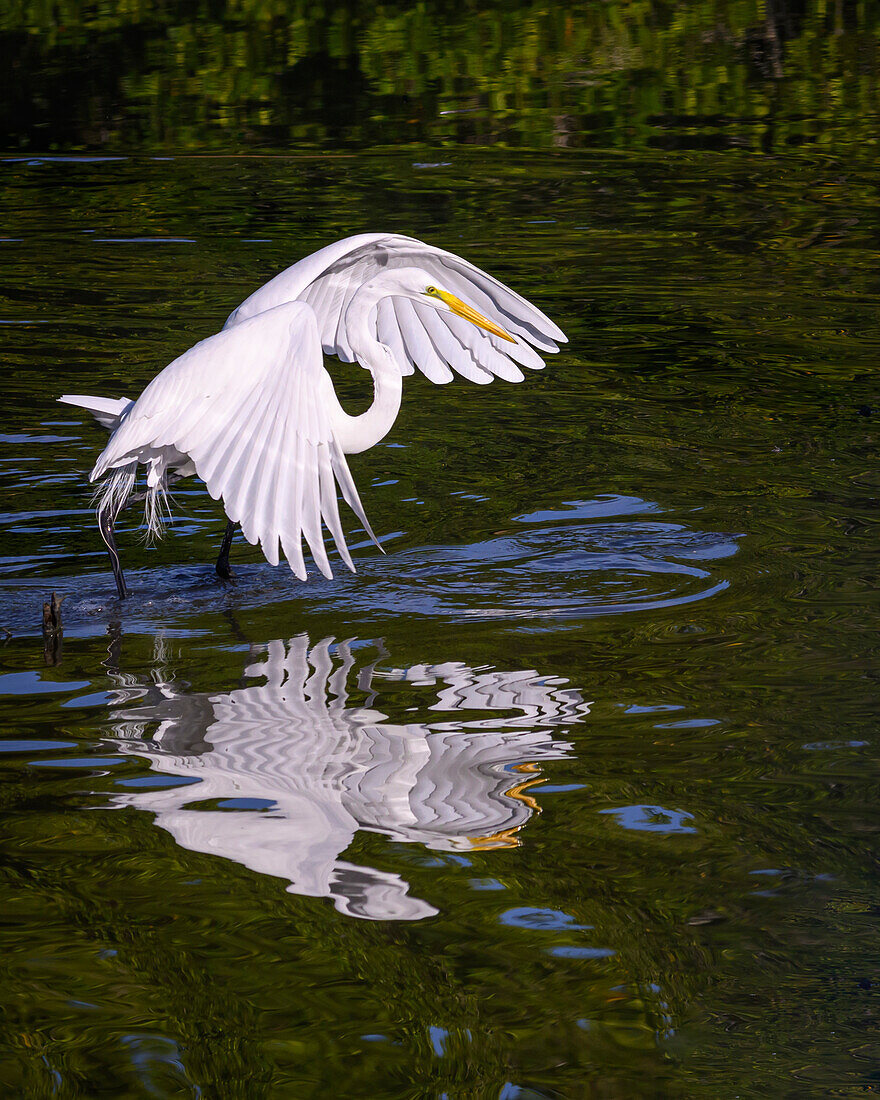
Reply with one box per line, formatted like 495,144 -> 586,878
331,276 -> 404,454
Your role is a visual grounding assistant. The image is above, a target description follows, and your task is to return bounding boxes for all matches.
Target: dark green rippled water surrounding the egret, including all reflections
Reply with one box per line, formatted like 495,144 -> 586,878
0,3 -> 880,1100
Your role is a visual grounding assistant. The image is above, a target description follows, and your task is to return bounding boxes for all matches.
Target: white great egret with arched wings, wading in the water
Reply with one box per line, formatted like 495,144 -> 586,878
59,227 -> 567,598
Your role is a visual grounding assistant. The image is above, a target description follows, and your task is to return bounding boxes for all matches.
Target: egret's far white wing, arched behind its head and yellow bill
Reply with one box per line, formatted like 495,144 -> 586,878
227,233 -> 567,384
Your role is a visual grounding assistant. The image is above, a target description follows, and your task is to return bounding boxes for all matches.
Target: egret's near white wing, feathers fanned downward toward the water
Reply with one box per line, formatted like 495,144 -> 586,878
91,301 -> 378,581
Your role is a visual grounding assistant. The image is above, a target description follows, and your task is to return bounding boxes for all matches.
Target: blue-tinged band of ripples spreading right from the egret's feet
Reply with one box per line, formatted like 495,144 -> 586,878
0,496 -> 738,631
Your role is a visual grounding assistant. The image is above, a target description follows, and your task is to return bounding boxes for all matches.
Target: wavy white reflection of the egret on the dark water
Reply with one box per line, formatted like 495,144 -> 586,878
110,635 -> 590,921
